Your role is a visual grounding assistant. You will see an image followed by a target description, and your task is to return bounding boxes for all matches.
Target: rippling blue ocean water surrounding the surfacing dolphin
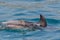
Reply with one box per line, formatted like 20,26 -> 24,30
0,0 -> 60,40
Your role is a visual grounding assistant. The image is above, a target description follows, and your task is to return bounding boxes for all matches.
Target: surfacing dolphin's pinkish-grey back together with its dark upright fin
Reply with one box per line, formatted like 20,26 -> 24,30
0,15 -> 47,29
